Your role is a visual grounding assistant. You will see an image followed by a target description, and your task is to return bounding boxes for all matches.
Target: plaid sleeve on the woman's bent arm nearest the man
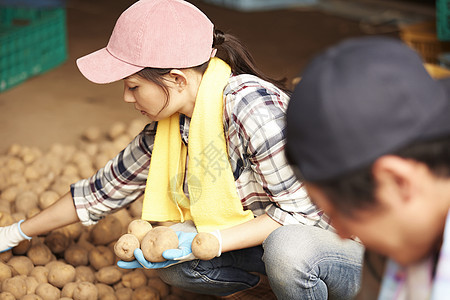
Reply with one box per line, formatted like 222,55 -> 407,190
234,87 -> 328,228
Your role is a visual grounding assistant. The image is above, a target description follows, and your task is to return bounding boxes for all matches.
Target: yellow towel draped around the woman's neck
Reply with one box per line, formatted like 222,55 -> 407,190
142,58 -> 254,232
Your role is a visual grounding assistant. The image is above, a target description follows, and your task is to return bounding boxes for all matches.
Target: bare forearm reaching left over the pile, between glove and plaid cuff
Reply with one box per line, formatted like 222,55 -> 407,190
21,192 -> 79,236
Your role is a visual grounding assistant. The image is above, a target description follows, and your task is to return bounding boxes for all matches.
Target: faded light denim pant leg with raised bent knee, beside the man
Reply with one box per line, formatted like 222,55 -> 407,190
263,225 -> 364,300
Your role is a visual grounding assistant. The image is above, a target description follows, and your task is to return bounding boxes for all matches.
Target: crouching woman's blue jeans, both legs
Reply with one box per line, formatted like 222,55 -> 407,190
158,224 -> 364,300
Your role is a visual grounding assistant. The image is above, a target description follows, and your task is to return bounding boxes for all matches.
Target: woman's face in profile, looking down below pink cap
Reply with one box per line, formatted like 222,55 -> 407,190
123,75 -> 189,121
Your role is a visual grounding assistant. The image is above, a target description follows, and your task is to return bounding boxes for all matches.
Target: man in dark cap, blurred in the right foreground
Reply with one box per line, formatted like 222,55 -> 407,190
286,37 -> 450,300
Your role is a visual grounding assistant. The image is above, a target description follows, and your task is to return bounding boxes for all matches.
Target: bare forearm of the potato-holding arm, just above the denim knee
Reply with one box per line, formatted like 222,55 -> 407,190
220,214 -> 281,252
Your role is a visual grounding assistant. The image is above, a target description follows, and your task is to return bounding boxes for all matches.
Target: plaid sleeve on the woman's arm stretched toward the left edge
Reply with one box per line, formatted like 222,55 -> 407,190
71,123 -> 156,225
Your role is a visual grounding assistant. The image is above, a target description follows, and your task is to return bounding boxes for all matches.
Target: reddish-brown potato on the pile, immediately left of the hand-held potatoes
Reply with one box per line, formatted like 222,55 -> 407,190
91,216 -> 122,245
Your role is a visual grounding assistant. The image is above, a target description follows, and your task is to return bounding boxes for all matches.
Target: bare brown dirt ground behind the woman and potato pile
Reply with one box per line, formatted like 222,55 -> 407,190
0,0 -> 412,153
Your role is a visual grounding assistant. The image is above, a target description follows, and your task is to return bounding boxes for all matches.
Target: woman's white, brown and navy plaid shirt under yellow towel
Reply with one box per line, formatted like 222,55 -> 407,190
71,75 -> 331,229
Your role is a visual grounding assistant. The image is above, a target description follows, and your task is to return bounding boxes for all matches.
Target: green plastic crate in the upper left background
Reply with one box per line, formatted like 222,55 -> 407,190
0,6 -> 67,92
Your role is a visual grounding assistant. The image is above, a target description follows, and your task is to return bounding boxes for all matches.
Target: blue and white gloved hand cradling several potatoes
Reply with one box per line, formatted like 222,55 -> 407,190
117,230 -> 222,269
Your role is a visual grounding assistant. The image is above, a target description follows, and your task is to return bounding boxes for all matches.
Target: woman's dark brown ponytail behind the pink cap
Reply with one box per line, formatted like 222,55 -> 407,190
213,29 -> 290,93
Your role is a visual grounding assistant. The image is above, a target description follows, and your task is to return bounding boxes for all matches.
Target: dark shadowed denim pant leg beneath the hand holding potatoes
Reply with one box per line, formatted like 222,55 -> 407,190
158,246 -> 265,296
